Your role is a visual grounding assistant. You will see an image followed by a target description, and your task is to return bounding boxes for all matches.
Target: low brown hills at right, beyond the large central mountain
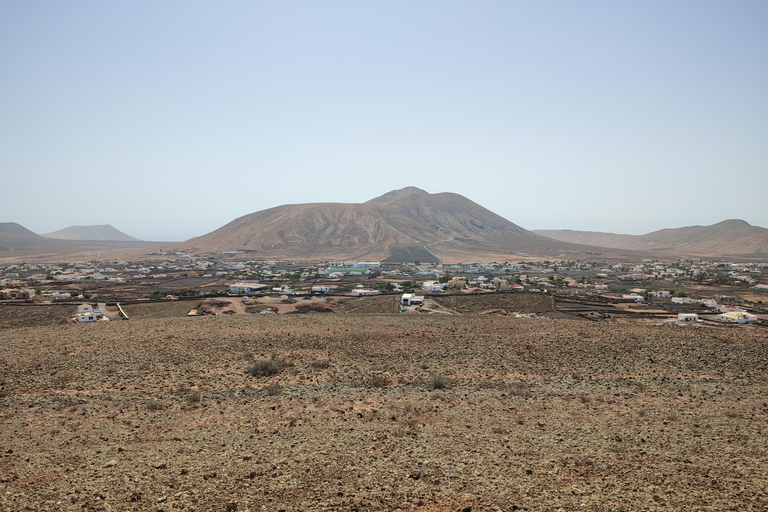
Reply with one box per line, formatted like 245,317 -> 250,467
534,219 -> 768,257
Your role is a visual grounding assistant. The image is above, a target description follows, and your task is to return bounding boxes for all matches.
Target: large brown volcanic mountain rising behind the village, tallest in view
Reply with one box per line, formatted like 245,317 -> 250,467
177,187 -> 589,262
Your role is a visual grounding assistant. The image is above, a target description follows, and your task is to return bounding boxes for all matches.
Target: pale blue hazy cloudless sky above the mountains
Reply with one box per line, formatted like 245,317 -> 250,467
0,0 -> 768,240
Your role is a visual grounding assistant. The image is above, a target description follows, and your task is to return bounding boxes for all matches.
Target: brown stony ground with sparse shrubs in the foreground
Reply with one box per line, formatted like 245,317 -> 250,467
0,314 -> 768,511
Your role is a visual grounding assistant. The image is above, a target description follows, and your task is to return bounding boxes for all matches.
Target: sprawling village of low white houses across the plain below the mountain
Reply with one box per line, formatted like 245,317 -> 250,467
0,252 -> 768,325
